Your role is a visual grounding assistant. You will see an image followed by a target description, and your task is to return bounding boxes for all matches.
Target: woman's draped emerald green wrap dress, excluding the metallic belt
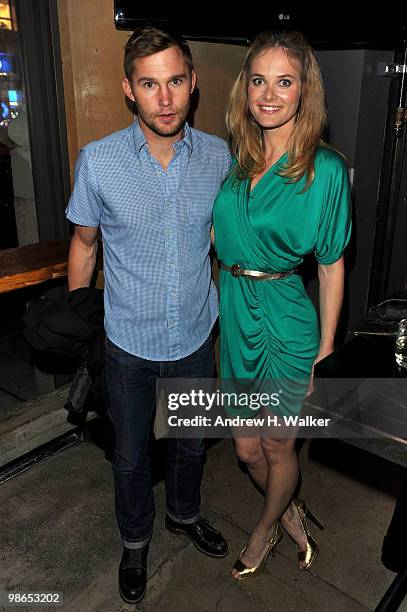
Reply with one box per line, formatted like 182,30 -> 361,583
213,147 -> 351,417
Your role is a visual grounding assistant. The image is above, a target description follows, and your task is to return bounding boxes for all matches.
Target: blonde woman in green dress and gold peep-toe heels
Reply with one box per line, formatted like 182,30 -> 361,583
214,32 -> 351,580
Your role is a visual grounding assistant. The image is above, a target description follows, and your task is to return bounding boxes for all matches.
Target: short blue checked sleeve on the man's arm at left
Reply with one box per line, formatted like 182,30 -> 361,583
65,149 -> 103,227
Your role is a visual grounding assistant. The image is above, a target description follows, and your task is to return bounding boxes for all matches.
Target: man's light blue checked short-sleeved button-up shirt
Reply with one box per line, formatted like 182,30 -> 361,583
66,121 -> 230,361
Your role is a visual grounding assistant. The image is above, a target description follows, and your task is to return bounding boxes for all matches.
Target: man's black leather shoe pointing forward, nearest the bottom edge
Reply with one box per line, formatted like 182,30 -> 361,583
119,544 -> 148,603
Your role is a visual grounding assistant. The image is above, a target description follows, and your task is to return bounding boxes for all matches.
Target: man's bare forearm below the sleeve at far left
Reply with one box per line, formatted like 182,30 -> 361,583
68,225 -> 98,291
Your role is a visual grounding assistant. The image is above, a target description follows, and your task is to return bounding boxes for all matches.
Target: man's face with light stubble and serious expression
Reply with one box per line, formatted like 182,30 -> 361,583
123,47 -> 196,138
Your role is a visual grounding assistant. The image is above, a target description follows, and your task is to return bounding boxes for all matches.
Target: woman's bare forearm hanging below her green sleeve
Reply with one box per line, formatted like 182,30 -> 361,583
314,256 -> 345,364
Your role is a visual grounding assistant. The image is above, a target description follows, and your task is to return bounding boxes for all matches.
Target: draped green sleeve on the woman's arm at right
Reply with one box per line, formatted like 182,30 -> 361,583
314,154 -> 352,265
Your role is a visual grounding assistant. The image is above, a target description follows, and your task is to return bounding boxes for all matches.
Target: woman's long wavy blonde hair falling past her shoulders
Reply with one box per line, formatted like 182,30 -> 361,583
226,31 -> 327,189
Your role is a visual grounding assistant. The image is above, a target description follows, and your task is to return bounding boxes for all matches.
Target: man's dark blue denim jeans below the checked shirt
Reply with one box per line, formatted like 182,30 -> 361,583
105,336 -> 214,548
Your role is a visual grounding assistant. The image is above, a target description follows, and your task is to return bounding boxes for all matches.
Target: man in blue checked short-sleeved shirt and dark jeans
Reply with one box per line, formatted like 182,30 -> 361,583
66,26 -> 230,603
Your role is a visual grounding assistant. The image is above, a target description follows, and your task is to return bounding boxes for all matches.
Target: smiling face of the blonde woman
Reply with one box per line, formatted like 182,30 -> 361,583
248,47 -> 301,137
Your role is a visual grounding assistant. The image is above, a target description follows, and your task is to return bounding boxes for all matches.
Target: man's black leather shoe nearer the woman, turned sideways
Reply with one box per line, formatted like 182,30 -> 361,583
165,514 -> 229,557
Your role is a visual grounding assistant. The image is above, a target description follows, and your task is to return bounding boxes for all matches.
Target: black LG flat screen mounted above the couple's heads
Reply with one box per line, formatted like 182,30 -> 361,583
114,0 -> 407,49
